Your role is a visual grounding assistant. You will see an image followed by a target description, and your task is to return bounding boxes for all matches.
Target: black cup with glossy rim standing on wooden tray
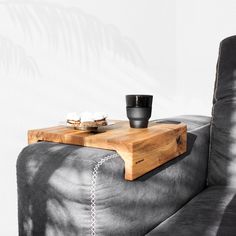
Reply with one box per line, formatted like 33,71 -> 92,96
126,95 -> 153,128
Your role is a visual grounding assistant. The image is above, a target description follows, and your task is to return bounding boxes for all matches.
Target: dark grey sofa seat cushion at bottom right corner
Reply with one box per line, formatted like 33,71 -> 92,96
147,186 -> 236,236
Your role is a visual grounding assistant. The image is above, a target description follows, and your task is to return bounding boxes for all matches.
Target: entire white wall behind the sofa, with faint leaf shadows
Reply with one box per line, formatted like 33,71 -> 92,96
0,0 -> 236,236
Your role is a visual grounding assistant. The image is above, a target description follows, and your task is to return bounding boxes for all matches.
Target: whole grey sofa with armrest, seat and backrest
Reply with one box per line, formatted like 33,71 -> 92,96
17,36 -> 236,236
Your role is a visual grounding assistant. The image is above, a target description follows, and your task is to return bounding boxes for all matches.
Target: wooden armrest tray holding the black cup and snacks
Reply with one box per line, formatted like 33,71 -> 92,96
28,121 -> 187,180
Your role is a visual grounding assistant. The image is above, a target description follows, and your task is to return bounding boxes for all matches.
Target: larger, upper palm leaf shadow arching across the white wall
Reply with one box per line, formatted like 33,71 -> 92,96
0,0 -> 145,78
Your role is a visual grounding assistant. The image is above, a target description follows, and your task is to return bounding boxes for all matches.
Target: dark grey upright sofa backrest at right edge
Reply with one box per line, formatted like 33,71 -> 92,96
208,36 -> 236,187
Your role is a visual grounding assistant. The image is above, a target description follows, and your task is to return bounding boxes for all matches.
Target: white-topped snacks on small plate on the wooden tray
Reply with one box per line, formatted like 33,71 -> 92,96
67,112 -> 107,129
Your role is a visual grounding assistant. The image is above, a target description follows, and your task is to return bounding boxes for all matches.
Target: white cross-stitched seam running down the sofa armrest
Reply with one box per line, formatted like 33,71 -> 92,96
90,153 -> 119,236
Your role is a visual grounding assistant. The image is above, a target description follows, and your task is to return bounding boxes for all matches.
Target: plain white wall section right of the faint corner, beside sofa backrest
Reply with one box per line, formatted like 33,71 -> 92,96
176,0 -> 236,115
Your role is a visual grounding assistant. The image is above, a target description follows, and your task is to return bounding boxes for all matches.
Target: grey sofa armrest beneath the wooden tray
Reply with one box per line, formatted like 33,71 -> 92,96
17,116 -> 210,236
